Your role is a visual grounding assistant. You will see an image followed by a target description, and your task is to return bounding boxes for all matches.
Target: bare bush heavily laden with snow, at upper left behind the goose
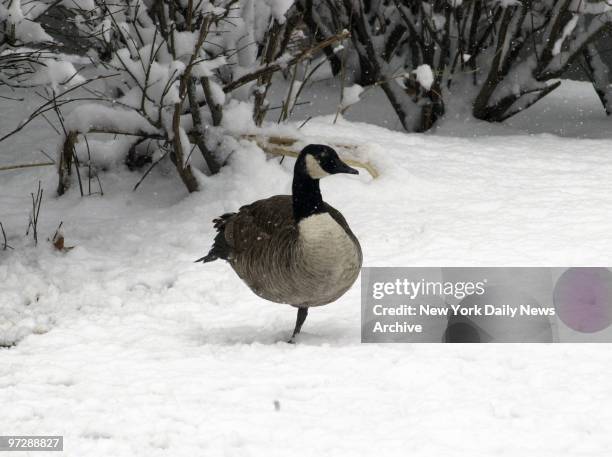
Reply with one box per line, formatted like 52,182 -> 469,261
50,0 -> 348,194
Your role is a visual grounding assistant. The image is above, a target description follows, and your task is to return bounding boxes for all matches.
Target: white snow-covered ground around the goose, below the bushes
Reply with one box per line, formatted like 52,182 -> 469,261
0,82 -> 612,457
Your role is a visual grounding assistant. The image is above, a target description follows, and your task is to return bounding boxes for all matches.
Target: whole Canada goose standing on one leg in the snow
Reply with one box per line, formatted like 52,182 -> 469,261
196,144 -> 362,343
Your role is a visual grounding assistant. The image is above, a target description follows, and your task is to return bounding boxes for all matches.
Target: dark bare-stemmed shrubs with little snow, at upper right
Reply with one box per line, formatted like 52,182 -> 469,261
297,0 -> 612,131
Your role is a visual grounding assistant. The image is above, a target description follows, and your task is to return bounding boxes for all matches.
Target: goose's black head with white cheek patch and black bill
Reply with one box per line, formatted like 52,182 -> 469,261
295,144 -> 359,179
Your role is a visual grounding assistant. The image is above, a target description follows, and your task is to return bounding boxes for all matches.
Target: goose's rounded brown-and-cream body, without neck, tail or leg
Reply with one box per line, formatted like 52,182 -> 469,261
220,195 -> 361,306
